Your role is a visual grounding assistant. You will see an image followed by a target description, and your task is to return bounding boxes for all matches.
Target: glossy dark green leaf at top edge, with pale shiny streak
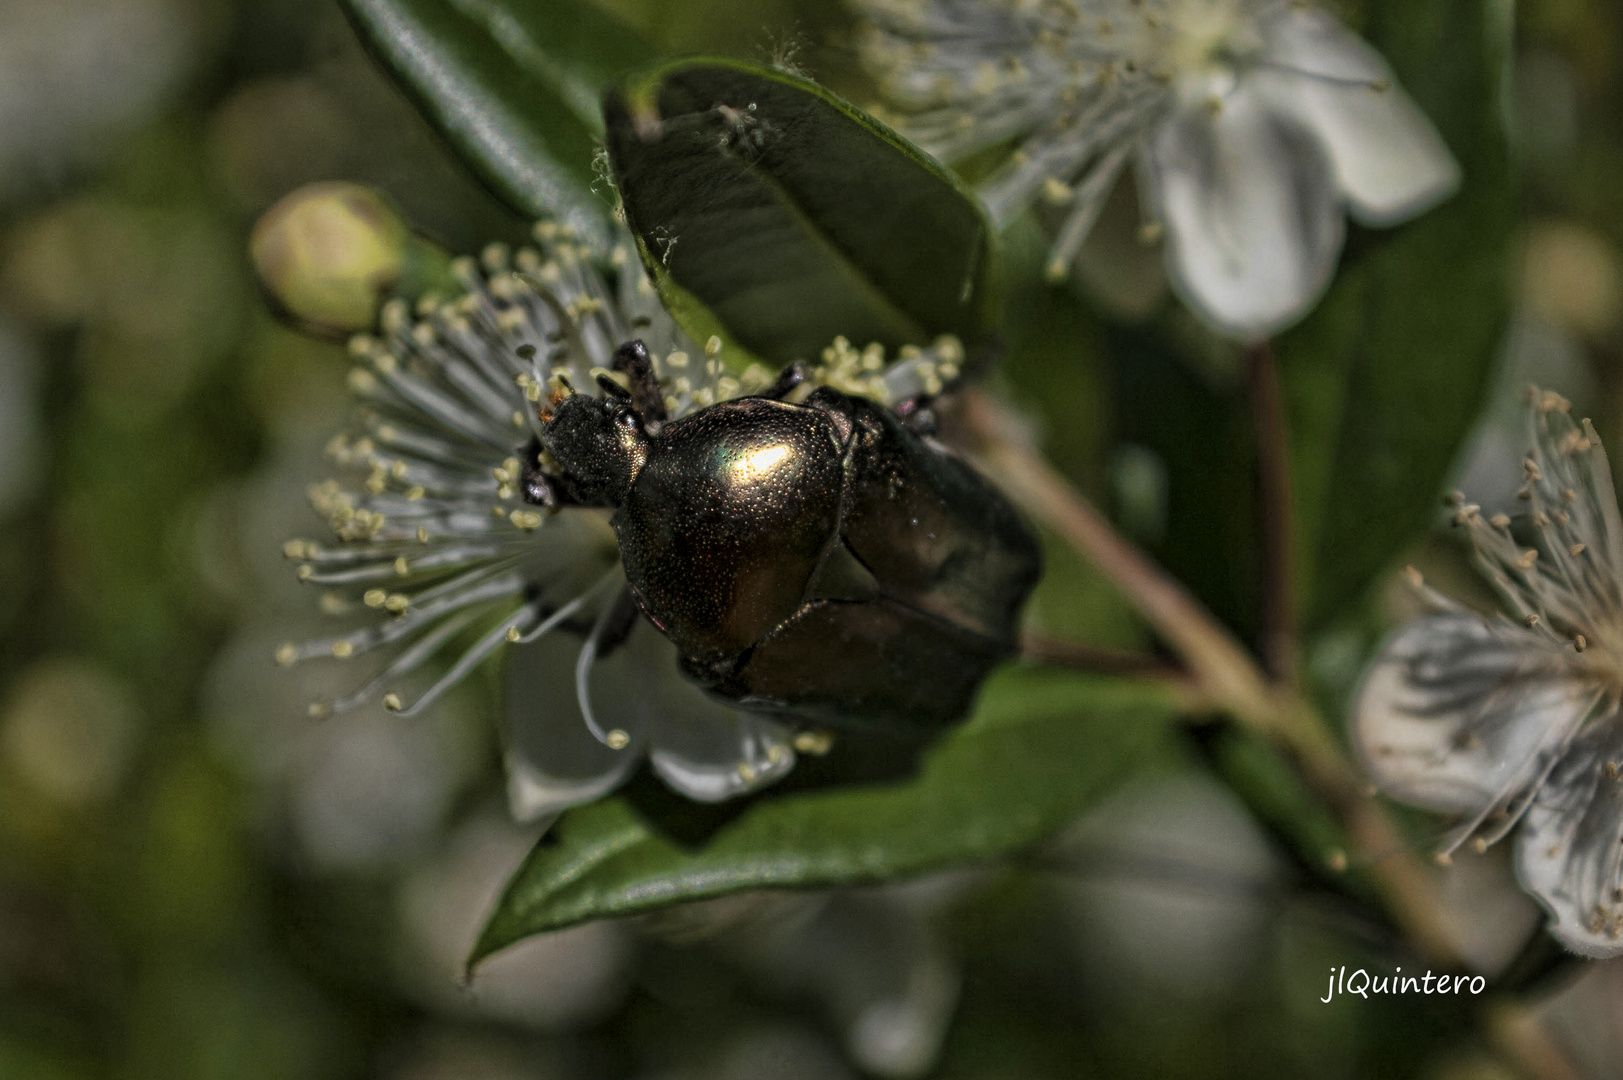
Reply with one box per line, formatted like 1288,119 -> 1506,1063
341,0 -> 649,225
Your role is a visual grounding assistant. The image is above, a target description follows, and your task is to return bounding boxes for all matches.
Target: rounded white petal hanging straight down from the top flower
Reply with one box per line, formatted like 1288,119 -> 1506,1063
1146,83 -> 1345,338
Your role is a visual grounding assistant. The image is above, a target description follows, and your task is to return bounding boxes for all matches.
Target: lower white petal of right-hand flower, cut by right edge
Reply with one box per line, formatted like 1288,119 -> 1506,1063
1516,715 -> 1623,958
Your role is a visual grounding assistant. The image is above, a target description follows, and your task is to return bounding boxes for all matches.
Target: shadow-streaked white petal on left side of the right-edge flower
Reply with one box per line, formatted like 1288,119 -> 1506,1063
1352,614 -> 1595,814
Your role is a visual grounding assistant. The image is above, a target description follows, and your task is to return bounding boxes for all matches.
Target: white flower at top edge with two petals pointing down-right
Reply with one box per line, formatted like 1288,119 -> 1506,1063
852,0 -> 1459,339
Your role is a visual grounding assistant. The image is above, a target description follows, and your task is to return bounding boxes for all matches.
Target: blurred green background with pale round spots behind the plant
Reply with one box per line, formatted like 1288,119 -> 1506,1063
0,0 -> 1623,1080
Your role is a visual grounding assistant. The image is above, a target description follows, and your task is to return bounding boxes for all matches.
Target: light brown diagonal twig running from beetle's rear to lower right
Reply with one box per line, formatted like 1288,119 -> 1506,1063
956,390 -> 1459,966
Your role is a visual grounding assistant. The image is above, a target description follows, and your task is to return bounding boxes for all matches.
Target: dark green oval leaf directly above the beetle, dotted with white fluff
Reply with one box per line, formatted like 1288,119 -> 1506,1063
604,60 -> 993,362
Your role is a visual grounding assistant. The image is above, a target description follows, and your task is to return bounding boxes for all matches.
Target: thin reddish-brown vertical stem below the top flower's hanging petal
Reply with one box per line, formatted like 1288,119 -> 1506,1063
1245,341 -> 1297,685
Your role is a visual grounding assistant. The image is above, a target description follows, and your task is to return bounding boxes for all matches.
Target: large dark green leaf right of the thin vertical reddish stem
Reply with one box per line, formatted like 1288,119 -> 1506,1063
1279,0 -> 1516,624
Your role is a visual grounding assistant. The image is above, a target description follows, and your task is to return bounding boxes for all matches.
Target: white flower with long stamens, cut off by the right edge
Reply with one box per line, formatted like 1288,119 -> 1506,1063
1352,391 -> 1623,957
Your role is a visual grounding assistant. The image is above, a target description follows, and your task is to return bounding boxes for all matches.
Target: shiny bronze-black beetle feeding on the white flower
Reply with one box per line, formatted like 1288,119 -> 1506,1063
524,341 -> 1042,729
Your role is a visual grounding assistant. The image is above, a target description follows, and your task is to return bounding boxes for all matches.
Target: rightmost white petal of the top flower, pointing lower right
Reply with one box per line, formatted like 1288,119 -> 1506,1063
1251,5 -> 1459,226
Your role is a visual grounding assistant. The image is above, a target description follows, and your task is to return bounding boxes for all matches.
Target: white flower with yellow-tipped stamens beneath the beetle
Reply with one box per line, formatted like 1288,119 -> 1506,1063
278,222 -> 956,820
